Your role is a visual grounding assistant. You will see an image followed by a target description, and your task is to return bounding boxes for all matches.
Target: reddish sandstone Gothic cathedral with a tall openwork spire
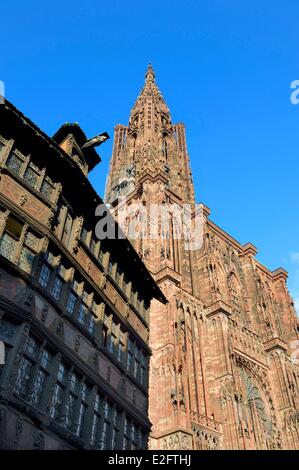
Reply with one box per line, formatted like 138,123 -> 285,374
105,65 -> 299,450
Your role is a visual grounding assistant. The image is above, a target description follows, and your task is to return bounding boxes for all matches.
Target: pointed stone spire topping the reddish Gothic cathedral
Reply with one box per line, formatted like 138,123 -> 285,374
106,64 -> 194,207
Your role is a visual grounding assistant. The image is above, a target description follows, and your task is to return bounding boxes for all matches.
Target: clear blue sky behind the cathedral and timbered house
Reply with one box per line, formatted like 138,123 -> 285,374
0,0 -> 299,312
